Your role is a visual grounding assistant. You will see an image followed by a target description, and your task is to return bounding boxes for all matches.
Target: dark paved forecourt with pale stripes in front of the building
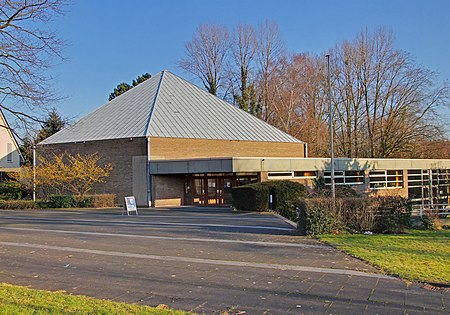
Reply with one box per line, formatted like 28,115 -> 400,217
0,207 -> 450,314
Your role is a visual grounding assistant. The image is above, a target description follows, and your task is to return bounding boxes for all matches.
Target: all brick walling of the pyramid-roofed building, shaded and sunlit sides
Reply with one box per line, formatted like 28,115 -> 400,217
37,138 -> 304,206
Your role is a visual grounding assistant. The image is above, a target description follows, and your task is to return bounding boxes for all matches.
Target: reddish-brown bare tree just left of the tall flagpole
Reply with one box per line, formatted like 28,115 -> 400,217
270,54 -> 329,156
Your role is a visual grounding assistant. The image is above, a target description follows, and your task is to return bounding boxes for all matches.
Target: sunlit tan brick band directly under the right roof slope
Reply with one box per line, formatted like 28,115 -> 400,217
150,137 -> 304,160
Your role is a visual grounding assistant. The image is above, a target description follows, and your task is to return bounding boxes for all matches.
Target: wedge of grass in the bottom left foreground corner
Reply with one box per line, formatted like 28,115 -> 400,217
0,283 -> 192,315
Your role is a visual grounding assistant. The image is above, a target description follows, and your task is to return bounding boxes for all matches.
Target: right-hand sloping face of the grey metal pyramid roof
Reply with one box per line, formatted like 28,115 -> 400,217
147,71 -> 301,142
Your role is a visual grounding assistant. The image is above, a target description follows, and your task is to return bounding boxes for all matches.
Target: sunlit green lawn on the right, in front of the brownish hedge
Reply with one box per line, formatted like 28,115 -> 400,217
319,230 -> 450,284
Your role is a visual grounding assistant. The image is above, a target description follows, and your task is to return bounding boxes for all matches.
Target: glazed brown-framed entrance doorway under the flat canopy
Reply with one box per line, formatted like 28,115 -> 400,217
184,173 -> 258,206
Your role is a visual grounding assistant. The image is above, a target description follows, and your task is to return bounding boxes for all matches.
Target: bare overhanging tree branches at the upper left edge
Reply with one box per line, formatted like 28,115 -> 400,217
0,0 -> 65,133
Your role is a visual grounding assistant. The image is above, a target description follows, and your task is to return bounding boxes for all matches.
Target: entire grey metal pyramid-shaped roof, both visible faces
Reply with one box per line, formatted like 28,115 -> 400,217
41,71 -> 301,144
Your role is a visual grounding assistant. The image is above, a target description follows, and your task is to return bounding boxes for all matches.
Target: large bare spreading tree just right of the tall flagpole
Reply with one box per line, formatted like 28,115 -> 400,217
331,29 -> 448,158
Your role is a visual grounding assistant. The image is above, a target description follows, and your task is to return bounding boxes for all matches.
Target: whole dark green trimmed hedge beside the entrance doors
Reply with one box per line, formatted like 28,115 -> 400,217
232,180 -> 308,221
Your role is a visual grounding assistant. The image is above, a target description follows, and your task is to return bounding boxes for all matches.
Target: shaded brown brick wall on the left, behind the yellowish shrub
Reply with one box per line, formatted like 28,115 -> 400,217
37,138 -> 147,204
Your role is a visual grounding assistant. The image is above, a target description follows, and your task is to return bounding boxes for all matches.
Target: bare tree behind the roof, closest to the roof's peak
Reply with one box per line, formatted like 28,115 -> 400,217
179,24 -> 229,95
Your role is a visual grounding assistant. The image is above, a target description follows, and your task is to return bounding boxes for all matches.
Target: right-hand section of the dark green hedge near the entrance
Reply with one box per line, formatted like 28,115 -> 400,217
268,180 -> 308,222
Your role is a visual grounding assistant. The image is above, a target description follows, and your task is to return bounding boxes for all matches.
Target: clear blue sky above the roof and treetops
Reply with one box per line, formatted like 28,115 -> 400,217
51,0 -> 450,126
